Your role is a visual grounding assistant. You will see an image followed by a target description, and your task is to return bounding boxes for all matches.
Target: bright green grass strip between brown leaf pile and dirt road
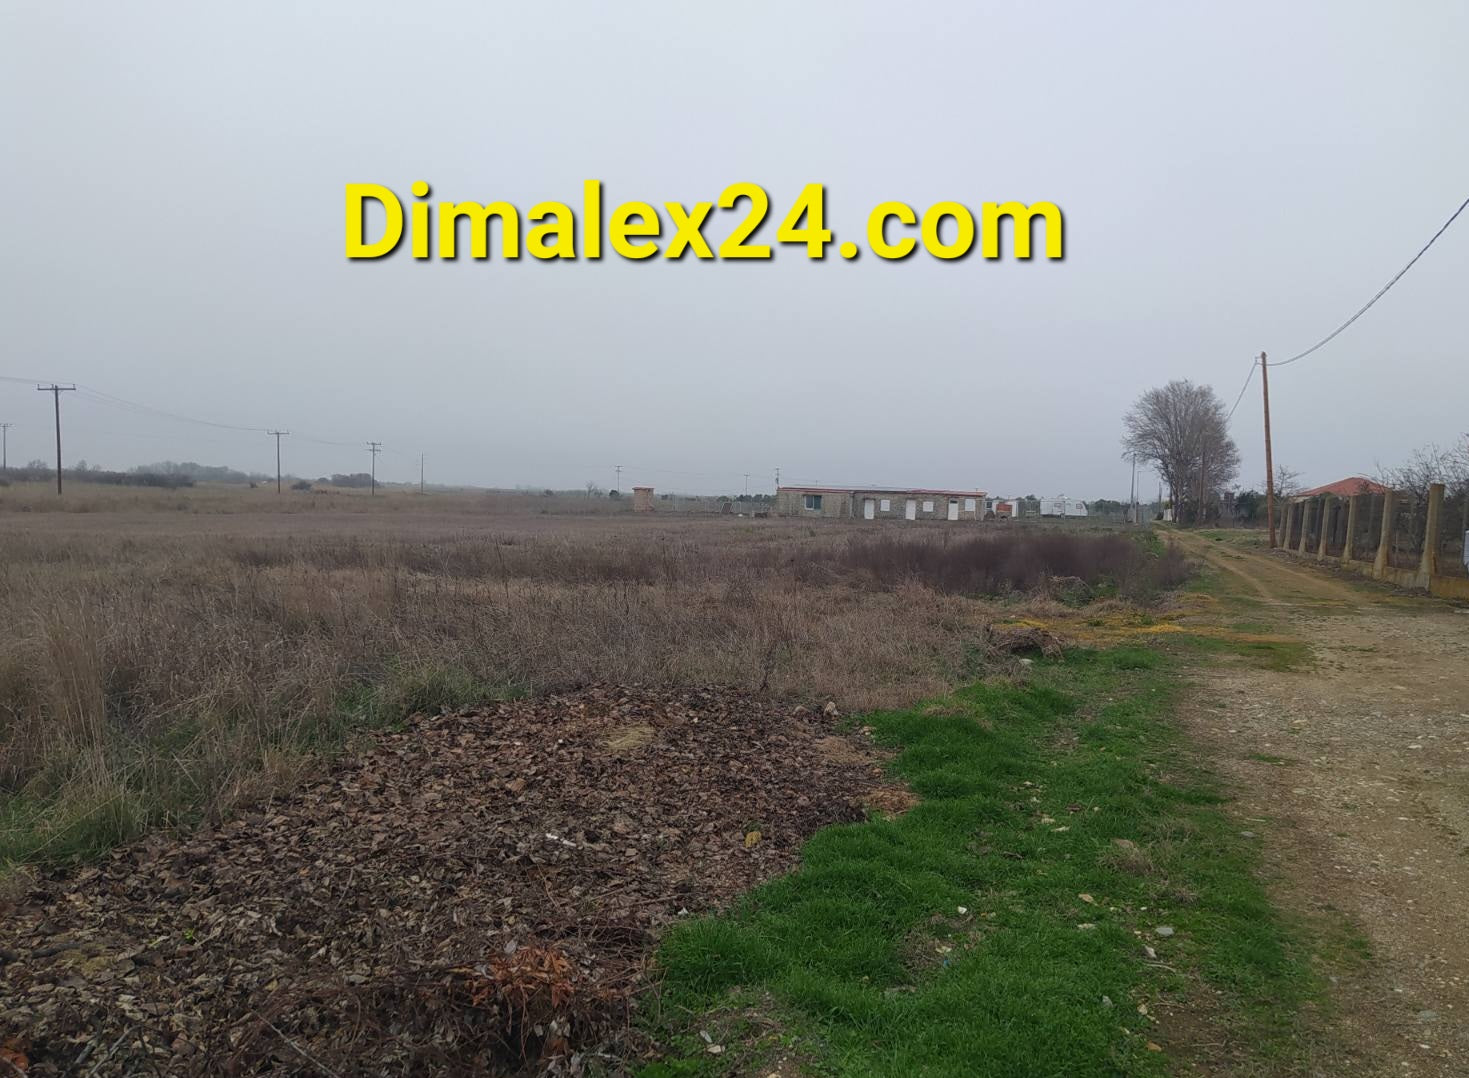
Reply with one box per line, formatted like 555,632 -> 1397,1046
643,648 -> 1315,1078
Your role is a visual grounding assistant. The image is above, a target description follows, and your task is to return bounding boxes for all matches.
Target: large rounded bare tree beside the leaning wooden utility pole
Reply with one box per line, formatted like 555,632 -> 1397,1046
1122,379 -> 1240,523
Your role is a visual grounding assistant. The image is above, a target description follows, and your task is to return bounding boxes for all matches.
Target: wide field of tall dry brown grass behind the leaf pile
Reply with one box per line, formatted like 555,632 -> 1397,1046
0,483 -> 1181,881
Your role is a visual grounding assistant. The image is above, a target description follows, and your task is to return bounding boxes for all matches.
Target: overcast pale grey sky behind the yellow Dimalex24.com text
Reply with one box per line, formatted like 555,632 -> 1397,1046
0,0 -> 1469,498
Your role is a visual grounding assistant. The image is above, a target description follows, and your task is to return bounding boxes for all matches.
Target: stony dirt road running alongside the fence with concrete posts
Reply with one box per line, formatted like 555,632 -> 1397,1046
1177,535 -> 1469,1078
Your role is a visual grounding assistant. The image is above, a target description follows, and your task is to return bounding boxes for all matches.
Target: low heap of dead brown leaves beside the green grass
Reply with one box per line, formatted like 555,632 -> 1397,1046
0,687 -> 884,1075
